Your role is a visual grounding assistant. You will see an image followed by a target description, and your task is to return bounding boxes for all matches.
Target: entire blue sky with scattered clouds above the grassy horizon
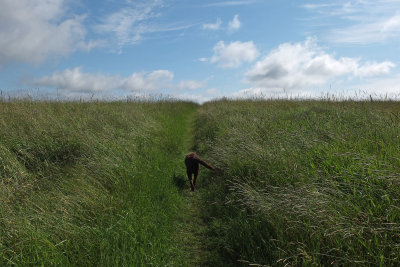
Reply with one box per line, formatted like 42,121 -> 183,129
0,0 -> 400,103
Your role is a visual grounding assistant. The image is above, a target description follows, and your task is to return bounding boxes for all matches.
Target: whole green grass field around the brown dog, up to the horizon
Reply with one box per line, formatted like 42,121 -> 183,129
0,100 -> 400,266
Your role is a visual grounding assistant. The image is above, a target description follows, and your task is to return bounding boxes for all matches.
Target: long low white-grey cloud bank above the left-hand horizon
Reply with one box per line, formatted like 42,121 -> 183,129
25,67 -> 207,93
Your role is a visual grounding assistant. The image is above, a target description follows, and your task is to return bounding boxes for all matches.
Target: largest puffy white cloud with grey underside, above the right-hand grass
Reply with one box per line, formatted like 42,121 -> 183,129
245,39 -> 395,90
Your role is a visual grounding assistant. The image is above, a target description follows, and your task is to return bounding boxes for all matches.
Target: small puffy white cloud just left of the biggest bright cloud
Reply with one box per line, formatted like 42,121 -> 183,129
210,41 -> 259,68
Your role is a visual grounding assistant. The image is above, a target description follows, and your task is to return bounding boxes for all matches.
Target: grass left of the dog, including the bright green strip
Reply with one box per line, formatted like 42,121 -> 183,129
0,101 -> 197,266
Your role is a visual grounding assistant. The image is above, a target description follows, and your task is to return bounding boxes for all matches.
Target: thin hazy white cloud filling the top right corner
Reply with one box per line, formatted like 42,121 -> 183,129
303,0 -> 400,44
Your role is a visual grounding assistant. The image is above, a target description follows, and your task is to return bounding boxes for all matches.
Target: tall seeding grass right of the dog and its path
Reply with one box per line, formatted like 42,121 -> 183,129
194,101 -> 400,266
